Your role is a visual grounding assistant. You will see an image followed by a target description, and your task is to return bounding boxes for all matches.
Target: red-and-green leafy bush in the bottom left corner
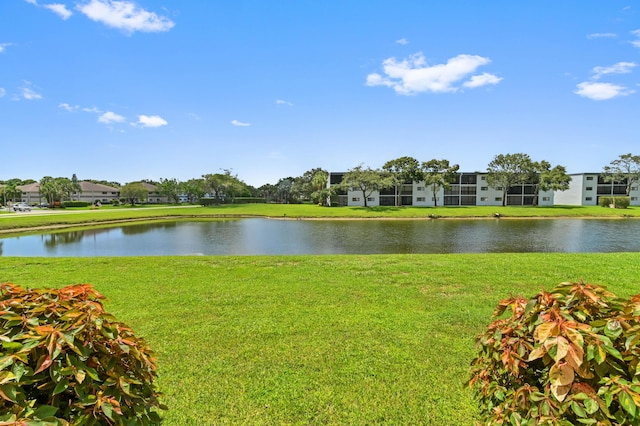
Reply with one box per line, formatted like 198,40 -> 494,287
0,283 -> 166,425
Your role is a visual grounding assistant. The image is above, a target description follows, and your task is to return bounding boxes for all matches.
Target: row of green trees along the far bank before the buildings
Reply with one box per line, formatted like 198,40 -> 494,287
5,153 -> 640,206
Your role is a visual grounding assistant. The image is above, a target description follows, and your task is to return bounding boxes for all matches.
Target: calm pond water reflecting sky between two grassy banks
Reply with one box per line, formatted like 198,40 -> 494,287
0,219 -> 640,257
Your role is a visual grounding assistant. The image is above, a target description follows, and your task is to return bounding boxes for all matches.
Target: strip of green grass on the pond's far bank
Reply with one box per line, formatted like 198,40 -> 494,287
0,204 -> 640,232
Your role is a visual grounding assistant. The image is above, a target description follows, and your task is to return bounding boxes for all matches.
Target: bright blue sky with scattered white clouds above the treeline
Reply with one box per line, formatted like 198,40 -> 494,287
0,0 -> 640,186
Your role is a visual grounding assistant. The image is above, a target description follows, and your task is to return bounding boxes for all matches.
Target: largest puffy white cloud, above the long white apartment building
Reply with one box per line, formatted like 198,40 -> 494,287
366,52 -> 500,95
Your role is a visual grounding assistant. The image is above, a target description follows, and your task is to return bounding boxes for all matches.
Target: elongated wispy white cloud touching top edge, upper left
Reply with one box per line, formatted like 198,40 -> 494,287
78,0 -> 175,33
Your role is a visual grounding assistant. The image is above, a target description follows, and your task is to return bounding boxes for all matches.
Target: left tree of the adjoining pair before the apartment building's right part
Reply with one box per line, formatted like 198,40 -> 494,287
487,153 -> 533,206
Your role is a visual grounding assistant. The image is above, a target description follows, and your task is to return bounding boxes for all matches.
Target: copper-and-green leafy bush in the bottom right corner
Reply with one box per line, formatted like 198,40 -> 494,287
469,282 -> 640,426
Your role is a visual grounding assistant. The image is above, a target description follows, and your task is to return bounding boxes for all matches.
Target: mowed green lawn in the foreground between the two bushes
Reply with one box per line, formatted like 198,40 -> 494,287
0,253 -> 640,425
